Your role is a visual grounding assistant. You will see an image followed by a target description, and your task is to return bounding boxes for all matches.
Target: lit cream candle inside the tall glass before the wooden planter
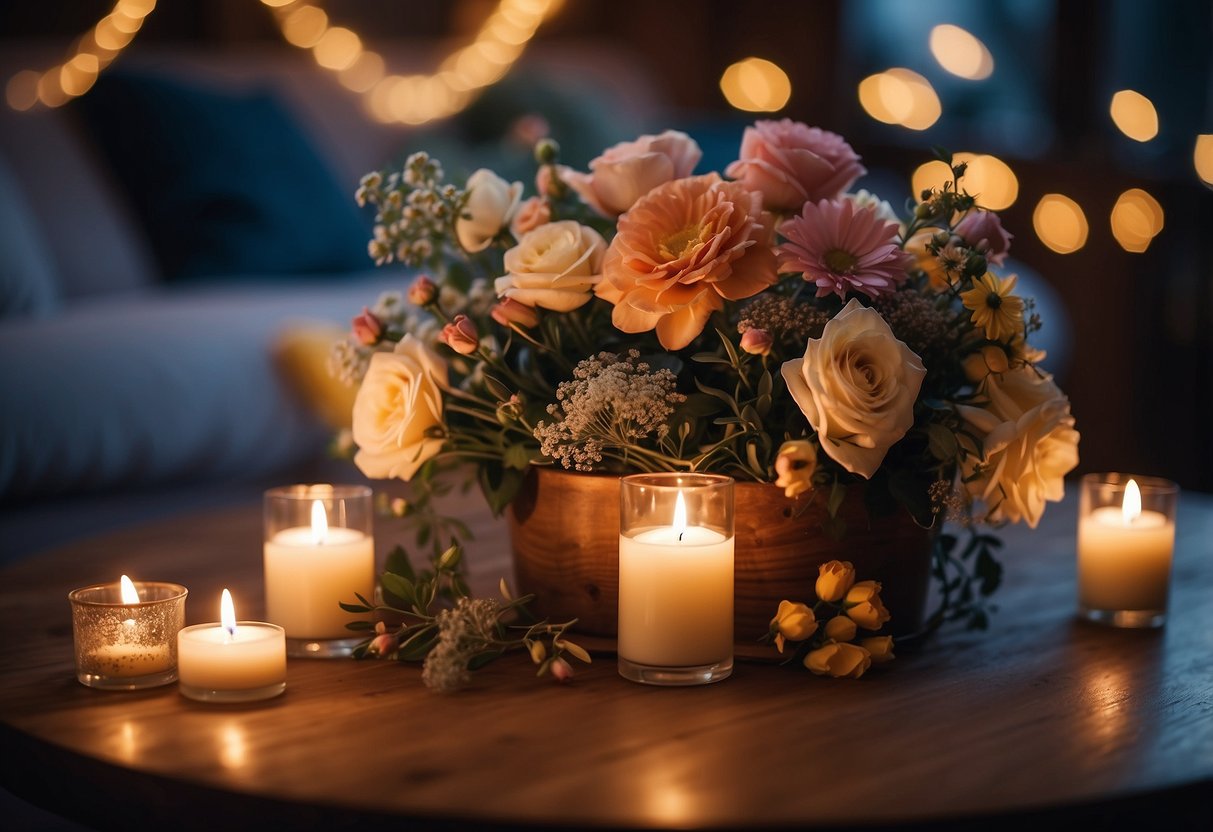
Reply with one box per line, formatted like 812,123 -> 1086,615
619,478 -> 734,684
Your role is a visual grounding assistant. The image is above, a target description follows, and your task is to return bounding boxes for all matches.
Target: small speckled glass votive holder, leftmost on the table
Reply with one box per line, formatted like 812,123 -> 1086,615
68,581 -> 189,690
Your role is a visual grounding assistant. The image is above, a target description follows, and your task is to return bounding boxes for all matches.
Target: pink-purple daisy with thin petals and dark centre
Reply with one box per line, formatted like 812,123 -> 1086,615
778,199 -> 913,300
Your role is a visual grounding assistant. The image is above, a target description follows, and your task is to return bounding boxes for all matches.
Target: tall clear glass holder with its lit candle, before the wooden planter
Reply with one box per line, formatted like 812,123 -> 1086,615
619,474 -> 734,685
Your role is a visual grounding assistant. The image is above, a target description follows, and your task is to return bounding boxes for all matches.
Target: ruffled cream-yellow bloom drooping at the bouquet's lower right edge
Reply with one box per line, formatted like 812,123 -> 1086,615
958,365 -> 1078,529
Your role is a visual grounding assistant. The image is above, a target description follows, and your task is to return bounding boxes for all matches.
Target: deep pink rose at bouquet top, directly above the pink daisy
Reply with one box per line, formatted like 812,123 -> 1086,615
724,119 -> 867,211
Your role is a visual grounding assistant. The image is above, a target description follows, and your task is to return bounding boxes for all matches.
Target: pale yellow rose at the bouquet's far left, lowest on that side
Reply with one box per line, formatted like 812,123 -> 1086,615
353,335 -> 446,480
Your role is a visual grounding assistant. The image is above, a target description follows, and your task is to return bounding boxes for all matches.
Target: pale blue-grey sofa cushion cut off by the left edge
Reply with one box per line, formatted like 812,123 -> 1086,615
0,156 -> 59,318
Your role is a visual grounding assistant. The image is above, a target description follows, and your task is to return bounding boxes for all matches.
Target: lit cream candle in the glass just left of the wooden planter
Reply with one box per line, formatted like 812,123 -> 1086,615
264,486 -> 375,655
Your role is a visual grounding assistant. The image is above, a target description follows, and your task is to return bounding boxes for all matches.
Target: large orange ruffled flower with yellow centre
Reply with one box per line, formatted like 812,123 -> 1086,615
594,173 -> 778,349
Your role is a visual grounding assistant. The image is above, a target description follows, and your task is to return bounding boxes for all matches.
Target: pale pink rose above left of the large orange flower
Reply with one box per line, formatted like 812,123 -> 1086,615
559,130 -> 704,217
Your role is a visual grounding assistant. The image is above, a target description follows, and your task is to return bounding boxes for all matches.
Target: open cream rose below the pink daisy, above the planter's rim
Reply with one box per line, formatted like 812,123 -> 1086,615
782,300 -> 927,478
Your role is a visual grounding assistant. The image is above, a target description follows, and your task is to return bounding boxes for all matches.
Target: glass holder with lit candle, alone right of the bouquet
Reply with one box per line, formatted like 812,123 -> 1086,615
1078,473 -> 1179,627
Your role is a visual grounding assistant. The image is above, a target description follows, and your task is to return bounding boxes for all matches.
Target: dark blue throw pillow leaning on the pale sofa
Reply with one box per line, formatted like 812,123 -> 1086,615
73,70 -> 370,279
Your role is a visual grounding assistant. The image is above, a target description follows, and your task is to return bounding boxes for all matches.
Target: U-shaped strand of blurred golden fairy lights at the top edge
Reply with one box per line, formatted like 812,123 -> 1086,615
261,0 -> 563,125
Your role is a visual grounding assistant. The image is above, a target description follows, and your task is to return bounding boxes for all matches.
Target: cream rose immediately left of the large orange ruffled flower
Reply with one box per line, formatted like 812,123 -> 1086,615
496,220 -> 607,312
